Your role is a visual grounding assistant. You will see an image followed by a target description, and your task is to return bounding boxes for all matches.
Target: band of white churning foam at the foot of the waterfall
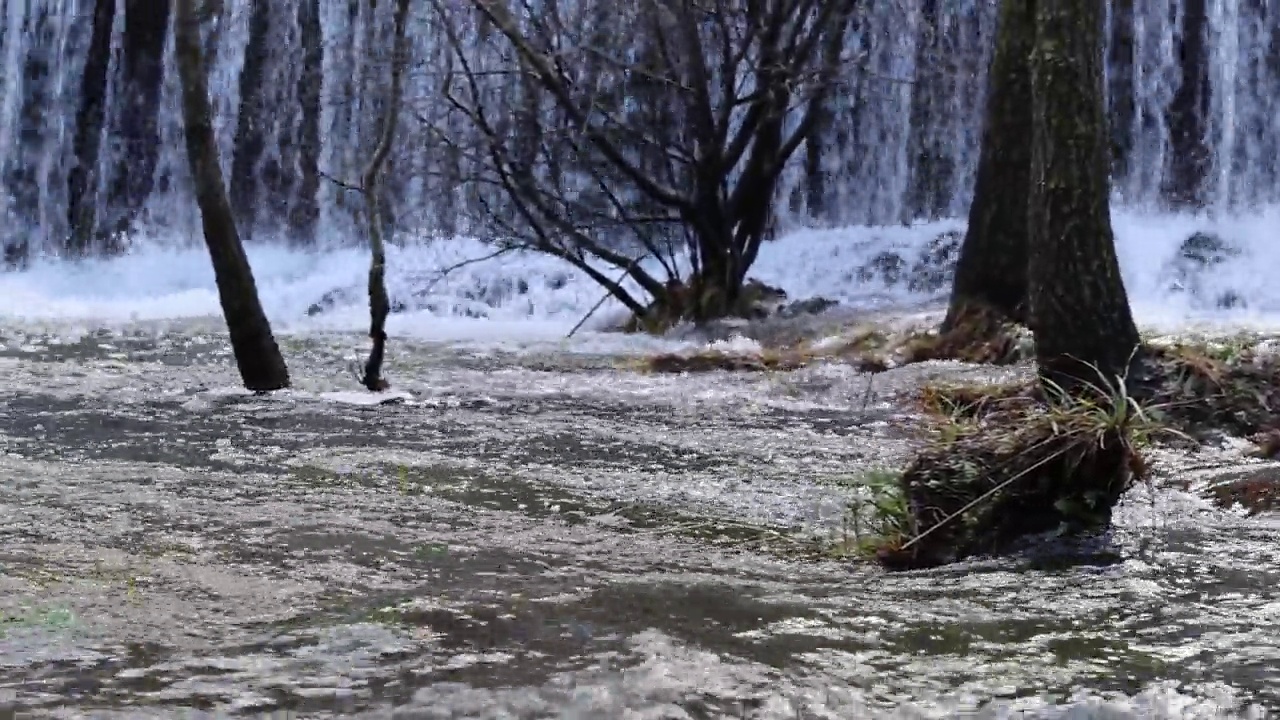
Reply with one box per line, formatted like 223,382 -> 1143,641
0,209 -> 1280,346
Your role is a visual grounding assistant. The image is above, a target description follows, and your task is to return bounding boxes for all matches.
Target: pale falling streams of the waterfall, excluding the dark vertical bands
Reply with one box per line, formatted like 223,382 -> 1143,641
0,0 -> 1280,247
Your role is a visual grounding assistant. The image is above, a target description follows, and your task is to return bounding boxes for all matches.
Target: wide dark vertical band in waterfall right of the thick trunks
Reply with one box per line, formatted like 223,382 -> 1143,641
1161,0 -> 1212,210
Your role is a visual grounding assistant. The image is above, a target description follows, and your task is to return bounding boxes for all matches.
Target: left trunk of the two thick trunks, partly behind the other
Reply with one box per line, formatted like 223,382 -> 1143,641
942,0 -> 1036,331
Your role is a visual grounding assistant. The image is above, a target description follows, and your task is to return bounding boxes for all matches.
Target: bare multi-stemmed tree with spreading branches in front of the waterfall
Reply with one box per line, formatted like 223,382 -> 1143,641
433,0 -> 856,320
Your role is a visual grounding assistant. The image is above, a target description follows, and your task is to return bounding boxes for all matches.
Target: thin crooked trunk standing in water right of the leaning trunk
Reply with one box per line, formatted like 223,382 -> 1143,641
360,0 -> 410,392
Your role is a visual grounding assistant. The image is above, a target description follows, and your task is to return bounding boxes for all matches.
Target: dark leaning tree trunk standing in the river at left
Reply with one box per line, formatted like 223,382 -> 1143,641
174,0 -> 289,391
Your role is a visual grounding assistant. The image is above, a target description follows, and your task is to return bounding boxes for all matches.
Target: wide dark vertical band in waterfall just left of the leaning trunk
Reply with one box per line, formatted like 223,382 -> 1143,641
104,0 -> 169,245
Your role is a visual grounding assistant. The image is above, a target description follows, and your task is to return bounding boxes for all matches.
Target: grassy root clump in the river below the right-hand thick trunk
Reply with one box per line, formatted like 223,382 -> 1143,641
876,361 -> 1162,569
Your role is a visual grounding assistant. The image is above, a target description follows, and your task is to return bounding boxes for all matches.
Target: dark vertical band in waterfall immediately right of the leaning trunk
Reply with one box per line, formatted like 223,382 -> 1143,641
230,0 -> 271,237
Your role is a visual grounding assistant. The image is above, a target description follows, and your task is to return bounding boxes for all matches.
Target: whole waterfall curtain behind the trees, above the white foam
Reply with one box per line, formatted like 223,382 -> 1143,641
0,0 -> 1280,257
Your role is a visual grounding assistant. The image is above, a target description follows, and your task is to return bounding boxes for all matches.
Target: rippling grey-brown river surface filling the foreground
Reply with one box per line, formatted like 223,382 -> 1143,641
0,323 -> 1280,720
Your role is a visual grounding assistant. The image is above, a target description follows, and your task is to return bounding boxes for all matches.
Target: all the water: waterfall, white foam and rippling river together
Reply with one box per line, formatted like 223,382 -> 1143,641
0,0 -> 1280,707
